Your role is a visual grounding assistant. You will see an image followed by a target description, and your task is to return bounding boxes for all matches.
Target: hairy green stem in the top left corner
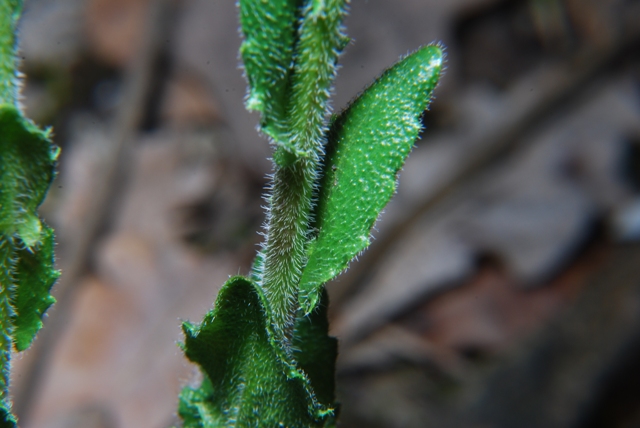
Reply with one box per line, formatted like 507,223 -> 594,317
0,0 -> 22,105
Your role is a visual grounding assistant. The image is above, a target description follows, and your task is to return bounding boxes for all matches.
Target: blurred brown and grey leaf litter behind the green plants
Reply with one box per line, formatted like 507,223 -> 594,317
12,0 -> 640,428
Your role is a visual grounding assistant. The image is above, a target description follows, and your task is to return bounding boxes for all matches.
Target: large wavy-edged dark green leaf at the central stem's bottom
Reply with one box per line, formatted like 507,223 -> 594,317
180,277 -> 333,428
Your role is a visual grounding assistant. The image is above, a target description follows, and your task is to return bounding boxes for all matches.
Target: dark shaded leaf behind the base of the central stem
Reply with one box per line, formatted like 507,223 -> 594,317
291,290 -> 338,405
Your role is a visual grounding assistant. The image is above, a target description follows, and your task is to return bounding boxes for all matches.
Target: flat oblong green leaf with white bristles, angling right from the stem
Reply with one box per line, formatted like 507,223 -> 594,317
299,46 -> 443,313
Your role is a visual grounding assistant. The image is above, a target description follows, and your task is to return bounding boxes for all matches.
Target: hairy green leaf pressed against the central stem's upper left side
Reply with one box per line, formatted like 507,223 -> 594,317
239,0 -> 302,140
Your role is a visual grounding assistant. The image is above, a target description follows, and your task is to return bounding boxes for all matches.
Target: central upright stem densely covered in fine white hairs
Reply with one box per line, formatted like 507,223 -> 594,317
258,0 -> 346,343
